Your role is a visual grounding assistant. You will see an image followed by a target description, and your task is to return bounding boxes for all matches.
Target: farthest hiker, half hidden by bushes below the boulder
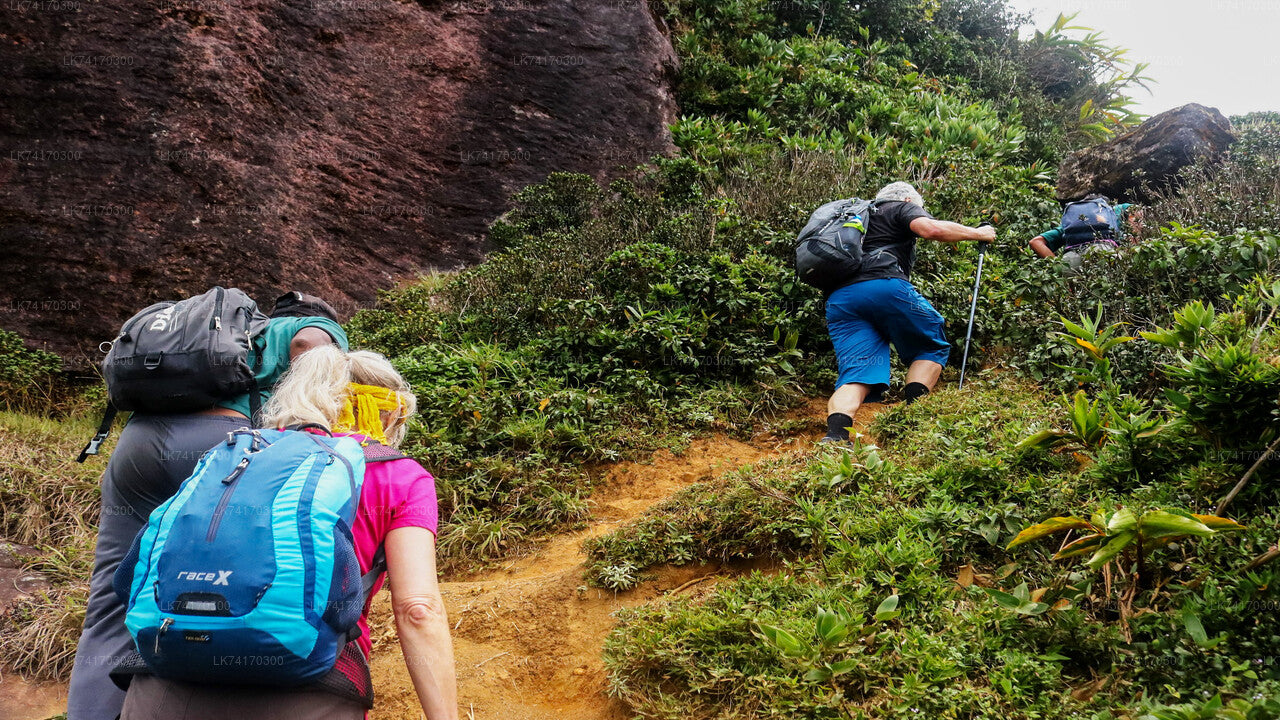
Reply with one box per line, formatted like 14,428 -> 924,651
1029,195 -> 1142,269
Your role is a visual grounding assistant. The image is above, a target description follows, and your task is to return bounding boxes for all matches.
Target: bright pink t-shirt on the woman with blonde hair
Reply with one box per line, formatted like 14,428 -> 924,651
351,436 -> 439,657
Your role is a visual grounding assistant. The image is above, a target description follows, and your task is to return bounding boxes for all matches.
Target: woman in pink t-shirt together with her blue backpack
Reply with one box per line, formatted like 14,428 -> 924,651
118,346 -> 458,720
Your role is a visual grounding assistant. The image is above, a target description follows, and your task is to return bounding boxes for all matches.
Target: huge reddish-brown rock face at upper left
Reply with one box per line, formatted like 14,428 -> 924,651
0,0 -> 676,365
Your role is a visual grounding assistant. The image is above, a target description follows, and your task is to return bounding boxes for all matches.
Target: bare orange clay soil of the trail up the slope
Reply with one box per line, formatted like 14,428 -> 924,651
370,401 -> 883,720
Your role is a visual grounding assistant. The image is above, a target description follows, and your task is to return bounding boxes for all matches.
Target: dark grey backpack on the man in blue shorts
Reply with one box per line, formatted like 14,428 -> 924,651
796,197 -> 897,295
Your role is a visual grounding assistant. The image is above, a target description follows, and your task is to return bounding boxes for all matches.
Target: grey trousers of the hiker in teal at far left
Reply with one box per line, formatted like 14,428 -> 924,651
67,414 -> 250,720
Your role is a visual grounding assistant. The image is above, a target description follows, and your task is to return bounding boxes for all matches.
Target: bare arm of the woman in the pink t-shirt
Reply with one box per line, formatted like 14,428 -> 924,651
387,520 -> 458,720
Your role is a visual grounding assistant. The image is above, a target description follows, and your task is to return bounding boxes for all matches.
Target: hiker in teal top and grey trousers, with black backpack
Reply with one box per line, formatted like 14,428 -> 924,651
67,288 -> 347,720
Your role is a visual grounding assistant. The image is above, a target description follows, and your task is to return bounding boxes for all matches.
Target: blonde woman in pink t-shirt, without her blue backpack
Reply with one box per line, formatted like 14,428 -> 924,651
122,347 -> 458,720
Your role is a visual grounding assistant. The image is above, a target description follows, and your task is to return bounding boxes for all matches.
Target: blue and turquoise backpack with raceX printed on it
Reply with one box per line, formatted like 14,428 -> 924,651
115,428 -> 402,685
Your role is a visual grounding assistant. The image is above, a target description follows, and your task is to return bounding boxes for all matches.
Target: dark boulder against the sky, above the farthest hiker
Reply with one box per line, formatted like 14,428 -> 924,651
1057,102 -> 1235,201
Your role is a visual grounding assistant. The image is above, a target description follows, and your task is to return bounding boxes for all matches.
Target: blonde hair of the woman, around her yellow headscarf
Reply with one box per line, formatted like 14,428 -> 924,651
262,345 -> 417,446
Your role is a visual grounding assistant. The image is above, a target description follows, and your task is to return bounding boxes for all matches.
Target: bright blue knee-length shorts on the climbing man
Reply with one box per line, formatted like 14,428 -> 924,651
827,278 -> 951,392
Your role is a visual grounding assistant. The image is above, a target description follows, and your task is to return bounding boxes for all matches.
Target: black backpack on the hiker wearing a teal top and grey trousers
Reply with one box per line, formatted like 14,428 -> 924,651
78,287 -> 268,462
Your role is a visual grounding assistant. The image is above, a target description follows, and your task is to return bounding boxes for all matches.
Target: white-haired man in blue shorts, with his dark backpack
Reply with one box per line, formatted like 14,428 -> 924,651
796,182 -> 996,442
